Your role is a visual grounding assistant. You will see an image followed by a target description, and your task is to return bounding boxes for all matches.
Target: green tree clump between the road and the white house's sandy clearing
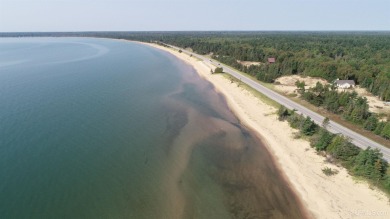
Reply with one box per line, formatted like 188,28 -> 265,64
296,81 -> 390,139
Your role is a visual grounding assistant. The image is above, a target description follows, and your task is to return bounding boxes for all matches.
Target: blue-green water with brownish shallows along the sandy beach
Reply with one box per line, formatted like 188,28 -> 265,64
0,38 -> 305,218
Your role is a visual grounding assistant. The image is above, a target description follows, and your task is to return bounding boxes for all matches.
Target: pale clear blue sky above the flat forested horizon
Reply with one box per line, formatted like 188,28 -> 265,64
0,0 -> 390,32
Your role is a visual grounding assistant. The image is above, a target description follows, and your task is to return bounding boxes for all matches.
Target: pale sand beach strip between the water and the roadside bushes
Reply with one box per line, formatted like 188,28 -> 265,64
140,44 -> 390,219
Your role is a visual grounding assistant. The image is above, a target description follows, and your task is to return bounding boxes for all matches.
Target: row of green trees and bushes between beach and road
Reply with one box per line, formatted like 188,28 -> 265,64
278,106 -> 390,193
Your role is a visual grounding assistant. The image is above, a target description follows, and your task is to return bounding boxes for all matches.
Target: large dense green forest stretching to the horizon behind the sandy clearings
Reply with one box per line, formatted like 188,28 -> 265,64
0,32 -> 390,101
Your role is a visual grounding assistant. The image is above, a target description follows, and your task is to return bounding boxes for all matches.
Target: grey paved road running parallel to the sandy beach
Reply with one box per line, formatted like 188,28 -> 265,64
171,43 -> 390,162
